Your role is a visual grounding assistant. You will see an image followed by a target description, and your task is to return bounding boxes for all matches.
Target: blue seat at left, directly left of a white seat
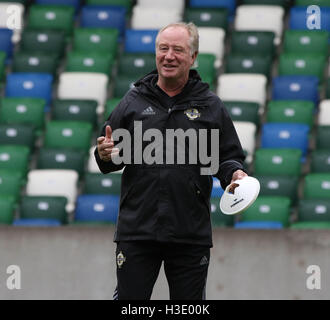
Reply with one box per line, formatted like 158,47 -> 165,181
5,72 -> 53,109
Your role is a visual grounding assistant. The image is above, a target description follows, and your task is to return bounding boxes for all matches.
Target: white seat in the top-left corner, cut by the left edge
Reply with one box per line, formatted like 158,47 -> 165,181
0,1 -> 25,43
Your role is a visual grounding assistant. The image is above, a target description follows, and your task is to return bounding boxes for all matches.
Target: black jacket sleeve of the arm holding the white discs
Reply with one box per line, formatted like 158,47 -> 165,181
215,100 -> 246,189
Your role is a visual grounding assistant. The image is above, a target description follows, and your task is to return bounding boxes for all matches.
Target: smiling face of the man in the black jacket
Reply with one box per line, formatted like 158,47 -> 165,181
156,26 -> 197,84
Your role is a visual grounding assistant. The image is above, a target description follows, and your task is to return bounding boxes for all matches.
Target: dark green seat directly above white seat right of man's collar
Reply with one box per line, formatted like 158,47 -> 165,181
226,53 -> 272,78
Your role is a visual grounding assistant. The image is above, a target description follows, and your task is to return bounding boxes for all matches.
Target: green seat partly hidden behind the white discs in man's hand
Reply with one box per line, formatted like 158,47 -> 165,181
240,196 -> 290,227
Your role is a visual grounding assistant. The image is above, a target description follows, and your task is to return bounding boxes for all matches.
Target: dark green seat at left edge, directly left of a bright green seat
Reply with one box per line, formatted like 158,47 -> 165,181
0,124 -> 36,150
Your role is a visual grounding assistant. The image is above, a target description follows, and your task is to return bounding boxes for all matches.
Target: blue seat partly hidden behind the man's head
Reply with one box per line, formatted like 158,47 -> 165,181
125,29 -> 158,53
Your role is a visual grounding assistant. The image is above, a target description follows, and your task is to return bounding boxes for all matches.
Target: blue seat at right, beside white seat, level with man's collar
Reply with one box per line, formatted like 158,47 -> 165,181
272,75 -> 319,105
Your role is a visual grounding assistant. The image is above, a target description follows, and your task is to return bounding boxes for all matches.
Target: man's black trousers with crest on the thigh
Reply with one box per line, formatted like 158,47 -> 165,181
114,241 -> 210,300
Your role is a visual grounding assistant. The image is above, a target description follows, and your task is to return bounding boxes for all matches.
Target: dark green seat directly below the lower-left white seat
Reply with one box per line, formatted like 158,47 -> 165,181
19,196 -> 68,224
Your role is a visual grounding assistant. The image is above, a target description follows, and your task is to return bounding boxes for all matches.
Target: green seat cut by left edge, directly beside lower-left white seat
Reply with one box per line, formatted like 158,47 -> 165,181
0,169 -> 24,202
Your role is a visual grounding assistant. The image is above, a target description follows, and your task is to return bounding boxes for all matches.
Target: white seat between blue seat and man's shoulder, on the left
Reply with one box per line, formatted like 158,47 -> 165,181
57,72 -> 108,114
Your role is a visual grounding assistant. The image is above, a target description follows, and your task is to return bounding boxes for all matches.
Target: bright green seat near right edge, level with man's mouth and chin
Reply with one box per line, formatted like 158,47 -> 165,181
278,53 -> 326,81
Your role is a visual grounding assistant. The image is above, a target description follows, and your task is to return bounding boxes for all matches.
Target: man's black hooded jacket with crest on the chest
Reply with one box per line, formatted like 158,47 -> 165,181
95,70 -> 244,246
